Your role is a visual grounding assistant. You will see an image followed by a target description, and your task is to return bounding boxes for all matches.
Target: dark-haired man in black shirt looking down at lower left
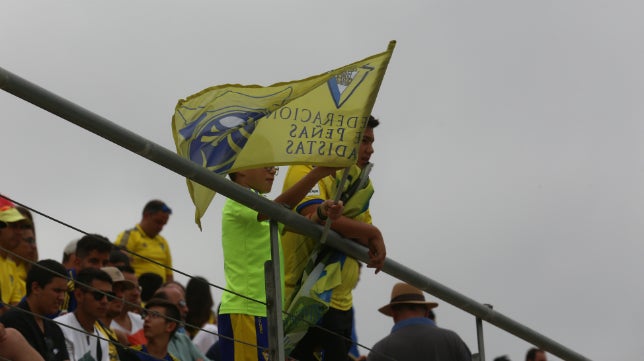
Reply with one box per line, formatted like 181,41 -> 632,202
0,259 -> 69,361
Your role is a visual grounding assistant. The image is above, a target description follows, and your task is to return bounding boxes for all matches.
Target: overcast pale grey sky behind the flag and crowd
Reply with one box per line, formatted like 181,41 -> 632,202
0,0 -> 644,361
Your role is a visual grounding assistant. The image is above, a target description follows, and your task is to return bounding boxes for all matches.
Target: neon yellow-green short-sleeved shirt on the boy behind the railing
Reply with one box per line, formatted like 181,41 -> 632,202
219,194 -> 284,317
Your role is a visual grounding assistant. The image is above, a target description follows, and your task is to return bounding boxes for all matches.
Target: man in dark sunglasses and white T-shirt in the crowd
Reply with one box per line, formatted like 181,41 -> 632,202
54,268 -> 114,361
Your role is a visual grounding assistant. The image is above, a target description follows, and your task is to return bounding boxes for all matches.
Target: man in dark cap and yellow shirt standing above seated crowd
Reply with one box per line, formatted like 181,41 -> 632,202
114,200 -> 174,283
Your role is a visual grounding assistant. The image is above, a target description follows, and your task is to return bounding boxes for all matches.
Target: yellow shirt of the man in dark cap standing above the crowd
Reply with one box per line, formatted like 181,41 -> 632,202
114,224 -> 172,282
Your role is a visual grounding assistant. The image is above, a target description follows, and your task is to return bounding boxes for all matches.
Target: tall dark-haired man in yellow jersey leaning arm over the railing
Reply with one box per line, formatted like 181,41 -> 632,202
282,116 -> 386,361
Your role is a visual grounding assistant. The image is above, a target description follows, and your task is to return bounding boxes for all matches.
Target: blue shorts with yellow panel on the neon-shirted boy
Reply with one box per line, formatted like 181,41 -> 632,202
217,313 -> 268,361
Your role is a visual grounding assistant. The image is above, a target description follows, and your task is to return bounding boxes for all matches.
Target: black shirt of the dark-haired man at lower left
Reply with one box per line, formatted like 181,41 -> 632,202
0,300 -> 69,361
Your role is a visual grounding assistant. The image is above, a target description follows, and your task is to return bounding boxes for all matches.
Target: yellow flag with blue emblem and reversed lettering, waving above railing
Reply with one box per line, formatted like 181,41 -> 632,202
172,41 -> 396,227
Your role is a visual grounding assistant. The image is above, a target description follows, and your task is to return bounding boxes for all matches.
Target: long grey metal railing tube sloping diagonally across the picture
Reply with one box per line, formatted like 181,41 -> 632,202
0,68 -> 589,361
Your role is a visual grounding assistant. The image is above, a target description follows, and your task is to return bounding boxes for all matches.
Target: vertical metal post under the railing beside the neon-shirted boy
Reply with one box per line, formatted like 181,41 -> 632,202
264,220 -> 286,360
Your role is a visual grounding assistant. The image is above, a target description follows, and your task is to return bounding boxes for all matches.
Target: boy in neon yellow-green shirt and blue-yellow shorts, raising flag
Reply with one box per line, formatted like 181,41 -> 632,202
218,167 -> 342,361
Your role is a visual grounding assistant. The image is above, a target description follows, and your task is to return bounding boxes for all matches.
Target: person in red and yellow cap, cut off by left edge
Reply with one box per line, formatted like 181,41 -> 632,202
0,197 -> 26,314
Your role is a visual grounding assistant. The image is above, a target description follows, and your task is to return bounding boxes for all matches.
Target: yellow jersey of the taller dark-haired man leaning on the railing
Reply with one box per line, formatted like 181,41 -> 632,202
282,165 -> 373,311
